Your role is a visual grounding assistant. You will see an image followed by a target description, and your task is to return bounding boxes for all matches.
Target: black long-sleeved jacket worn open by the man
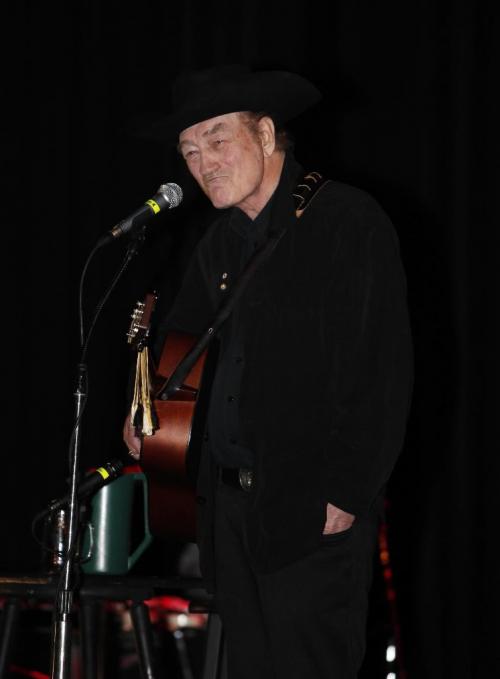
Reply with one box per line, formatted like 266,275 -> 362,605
158,157 -> 412,577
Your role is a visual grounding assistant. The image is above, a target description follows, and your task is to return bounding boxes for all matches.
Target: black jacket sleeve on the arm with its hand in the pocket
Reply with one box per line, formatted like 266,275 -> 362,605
325,200 -> 413,515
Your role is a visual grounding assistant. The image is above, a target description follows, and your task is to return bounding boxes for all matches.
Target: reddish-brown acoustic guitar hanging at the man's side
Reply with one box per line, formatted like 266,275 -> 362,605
127,293 -> 215,542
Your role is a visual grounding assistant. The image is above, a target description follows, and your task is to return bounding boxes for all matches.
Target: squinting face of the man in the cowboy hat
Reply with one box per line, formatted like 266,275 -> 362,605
179,113 -> 264,212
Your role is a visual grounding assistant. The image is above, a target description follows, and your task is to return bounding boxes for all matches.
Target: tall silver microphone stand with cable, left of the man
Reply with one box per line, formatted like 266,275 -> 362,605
50,227 -> 145,679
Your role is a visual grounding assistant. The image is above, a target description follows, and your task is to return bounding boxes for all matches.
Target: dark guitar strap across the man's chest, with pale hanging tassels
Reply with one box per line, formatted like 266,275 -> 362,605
130,172 -> 329,436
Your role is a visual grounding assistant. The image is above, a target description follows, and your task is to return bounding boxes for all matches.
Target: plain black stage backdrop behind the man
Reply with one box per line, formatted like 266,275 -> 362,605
5,0 -> 500,679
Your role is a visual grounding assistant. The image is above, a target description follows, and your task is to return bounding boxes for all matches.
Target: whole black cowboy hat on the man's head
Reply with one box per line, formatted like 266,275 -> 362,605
143,64 -> 321,142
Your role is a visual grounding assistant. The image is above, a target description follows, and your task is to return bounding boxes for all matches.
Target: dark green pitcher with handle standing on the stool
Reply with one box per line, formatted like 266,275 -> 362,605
81,467 -> 153,575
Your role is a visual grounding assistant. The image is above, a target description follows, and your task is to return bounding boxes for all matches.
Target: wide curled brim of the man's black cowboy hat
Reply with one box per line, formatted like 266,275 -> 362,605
143,71 -> 321,143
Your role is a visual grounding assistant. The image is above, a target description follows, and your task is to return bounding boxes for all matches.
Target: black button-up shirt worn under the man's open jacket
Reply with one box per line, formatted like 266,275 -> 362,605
207,198 -> 272,469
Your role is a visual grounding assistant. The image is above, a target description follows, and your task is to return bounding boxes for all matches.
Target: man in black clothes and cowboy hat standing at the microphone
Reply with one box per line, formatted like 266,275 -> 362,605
125,67 -> 412,679
